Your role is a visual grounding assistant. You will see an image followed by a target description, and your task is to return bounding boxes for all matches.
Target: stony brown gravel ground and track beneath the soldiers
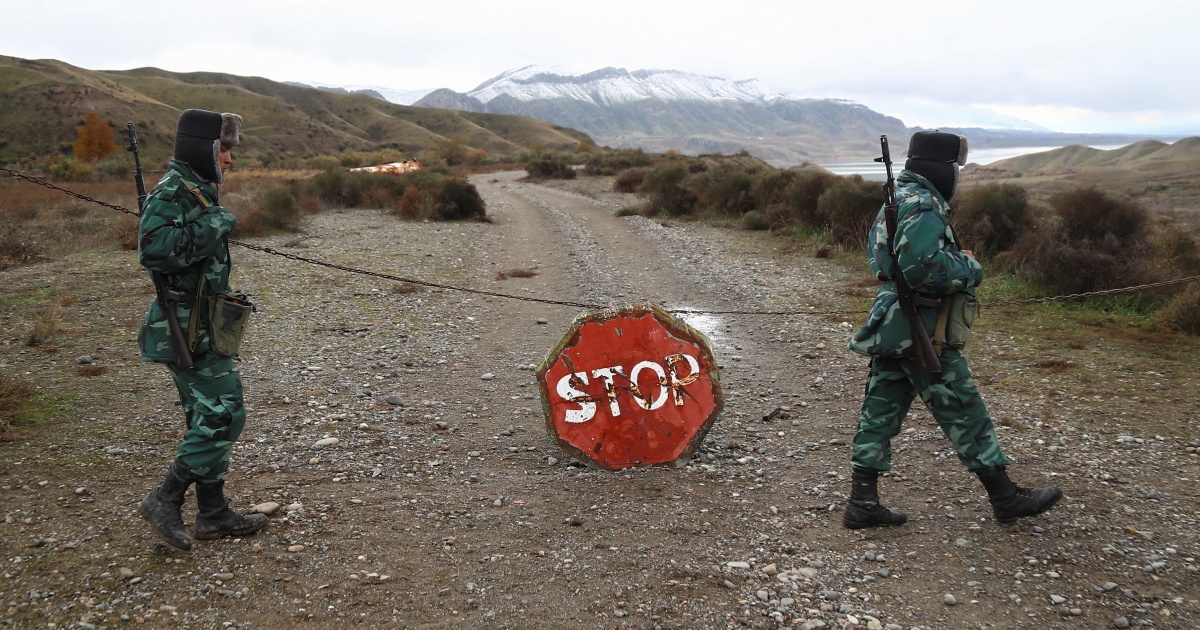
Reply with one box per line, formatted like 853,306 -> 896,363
0,173 -> 1200,629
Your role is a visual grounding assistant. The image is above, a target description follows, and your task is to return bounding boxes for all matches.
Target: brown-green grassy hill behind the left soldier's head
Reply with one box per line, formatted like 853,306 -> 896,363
0,55 -> 590,164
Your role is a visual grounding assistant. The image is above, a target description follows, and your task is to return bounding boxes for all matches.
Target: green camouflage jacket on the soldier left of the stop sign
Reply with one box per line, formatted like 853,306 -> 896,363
138,160 -> 238,362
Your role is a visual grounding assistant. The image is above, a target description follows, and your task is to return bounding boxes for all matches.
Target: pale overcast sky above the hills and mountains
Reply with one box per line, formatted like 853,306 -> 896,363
0,0 -> 1200,136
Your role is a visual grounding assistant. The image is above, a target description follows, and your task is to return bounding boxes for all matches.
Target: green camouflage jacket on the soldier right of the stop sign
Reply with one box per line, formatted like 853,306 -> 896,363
848,170 -> 983,358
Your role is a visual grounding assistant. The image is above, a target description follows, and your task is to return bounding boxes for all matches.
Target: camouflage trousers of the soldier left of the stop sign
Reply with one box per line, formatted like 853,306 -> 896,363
167,352 -> 246,482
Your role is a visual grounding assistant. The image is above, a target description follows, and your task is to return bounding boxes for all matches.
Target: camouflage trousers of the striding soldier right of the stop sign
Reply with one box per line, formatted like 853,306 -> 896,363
851,348 -> 1009,472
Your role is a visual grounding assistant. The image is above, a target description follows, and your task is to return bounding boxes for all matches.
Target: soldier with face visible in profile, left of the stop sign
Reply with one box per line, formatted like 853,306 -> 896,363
138,109 -> 266,550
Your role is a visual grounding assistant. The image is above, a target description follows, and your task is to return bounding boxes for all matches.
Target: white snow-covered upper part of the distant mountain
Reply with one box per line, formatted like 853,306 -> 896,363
467,66 -> 786,106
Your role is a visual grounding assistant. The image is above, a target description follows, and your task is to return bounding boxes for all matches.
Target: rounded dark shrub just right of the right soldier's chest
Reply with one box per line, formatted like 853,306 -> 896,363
952,182 -> 1034,254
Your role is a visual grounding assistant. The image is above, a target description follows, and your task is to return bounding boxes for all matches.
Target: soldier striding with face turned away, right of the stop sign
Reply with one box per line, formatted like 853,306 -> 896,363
842,131 -> 1062,529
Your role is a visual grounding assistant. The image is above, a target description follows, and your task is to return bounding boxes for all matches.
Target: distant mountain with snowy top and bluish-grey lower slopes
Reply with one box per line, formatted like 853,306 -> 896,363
414,66 -> 908,166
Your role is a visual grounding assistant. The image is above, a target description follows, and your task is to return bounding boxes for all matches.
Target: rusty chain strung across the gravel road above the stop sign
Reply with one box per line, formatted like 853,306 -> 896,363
0,167 -> 1200,316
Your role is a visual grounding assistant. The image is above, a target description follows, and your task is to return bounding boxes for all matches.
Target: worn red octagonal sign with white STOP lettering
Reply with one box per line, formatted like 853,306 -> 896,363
538,304 -> 724,470
